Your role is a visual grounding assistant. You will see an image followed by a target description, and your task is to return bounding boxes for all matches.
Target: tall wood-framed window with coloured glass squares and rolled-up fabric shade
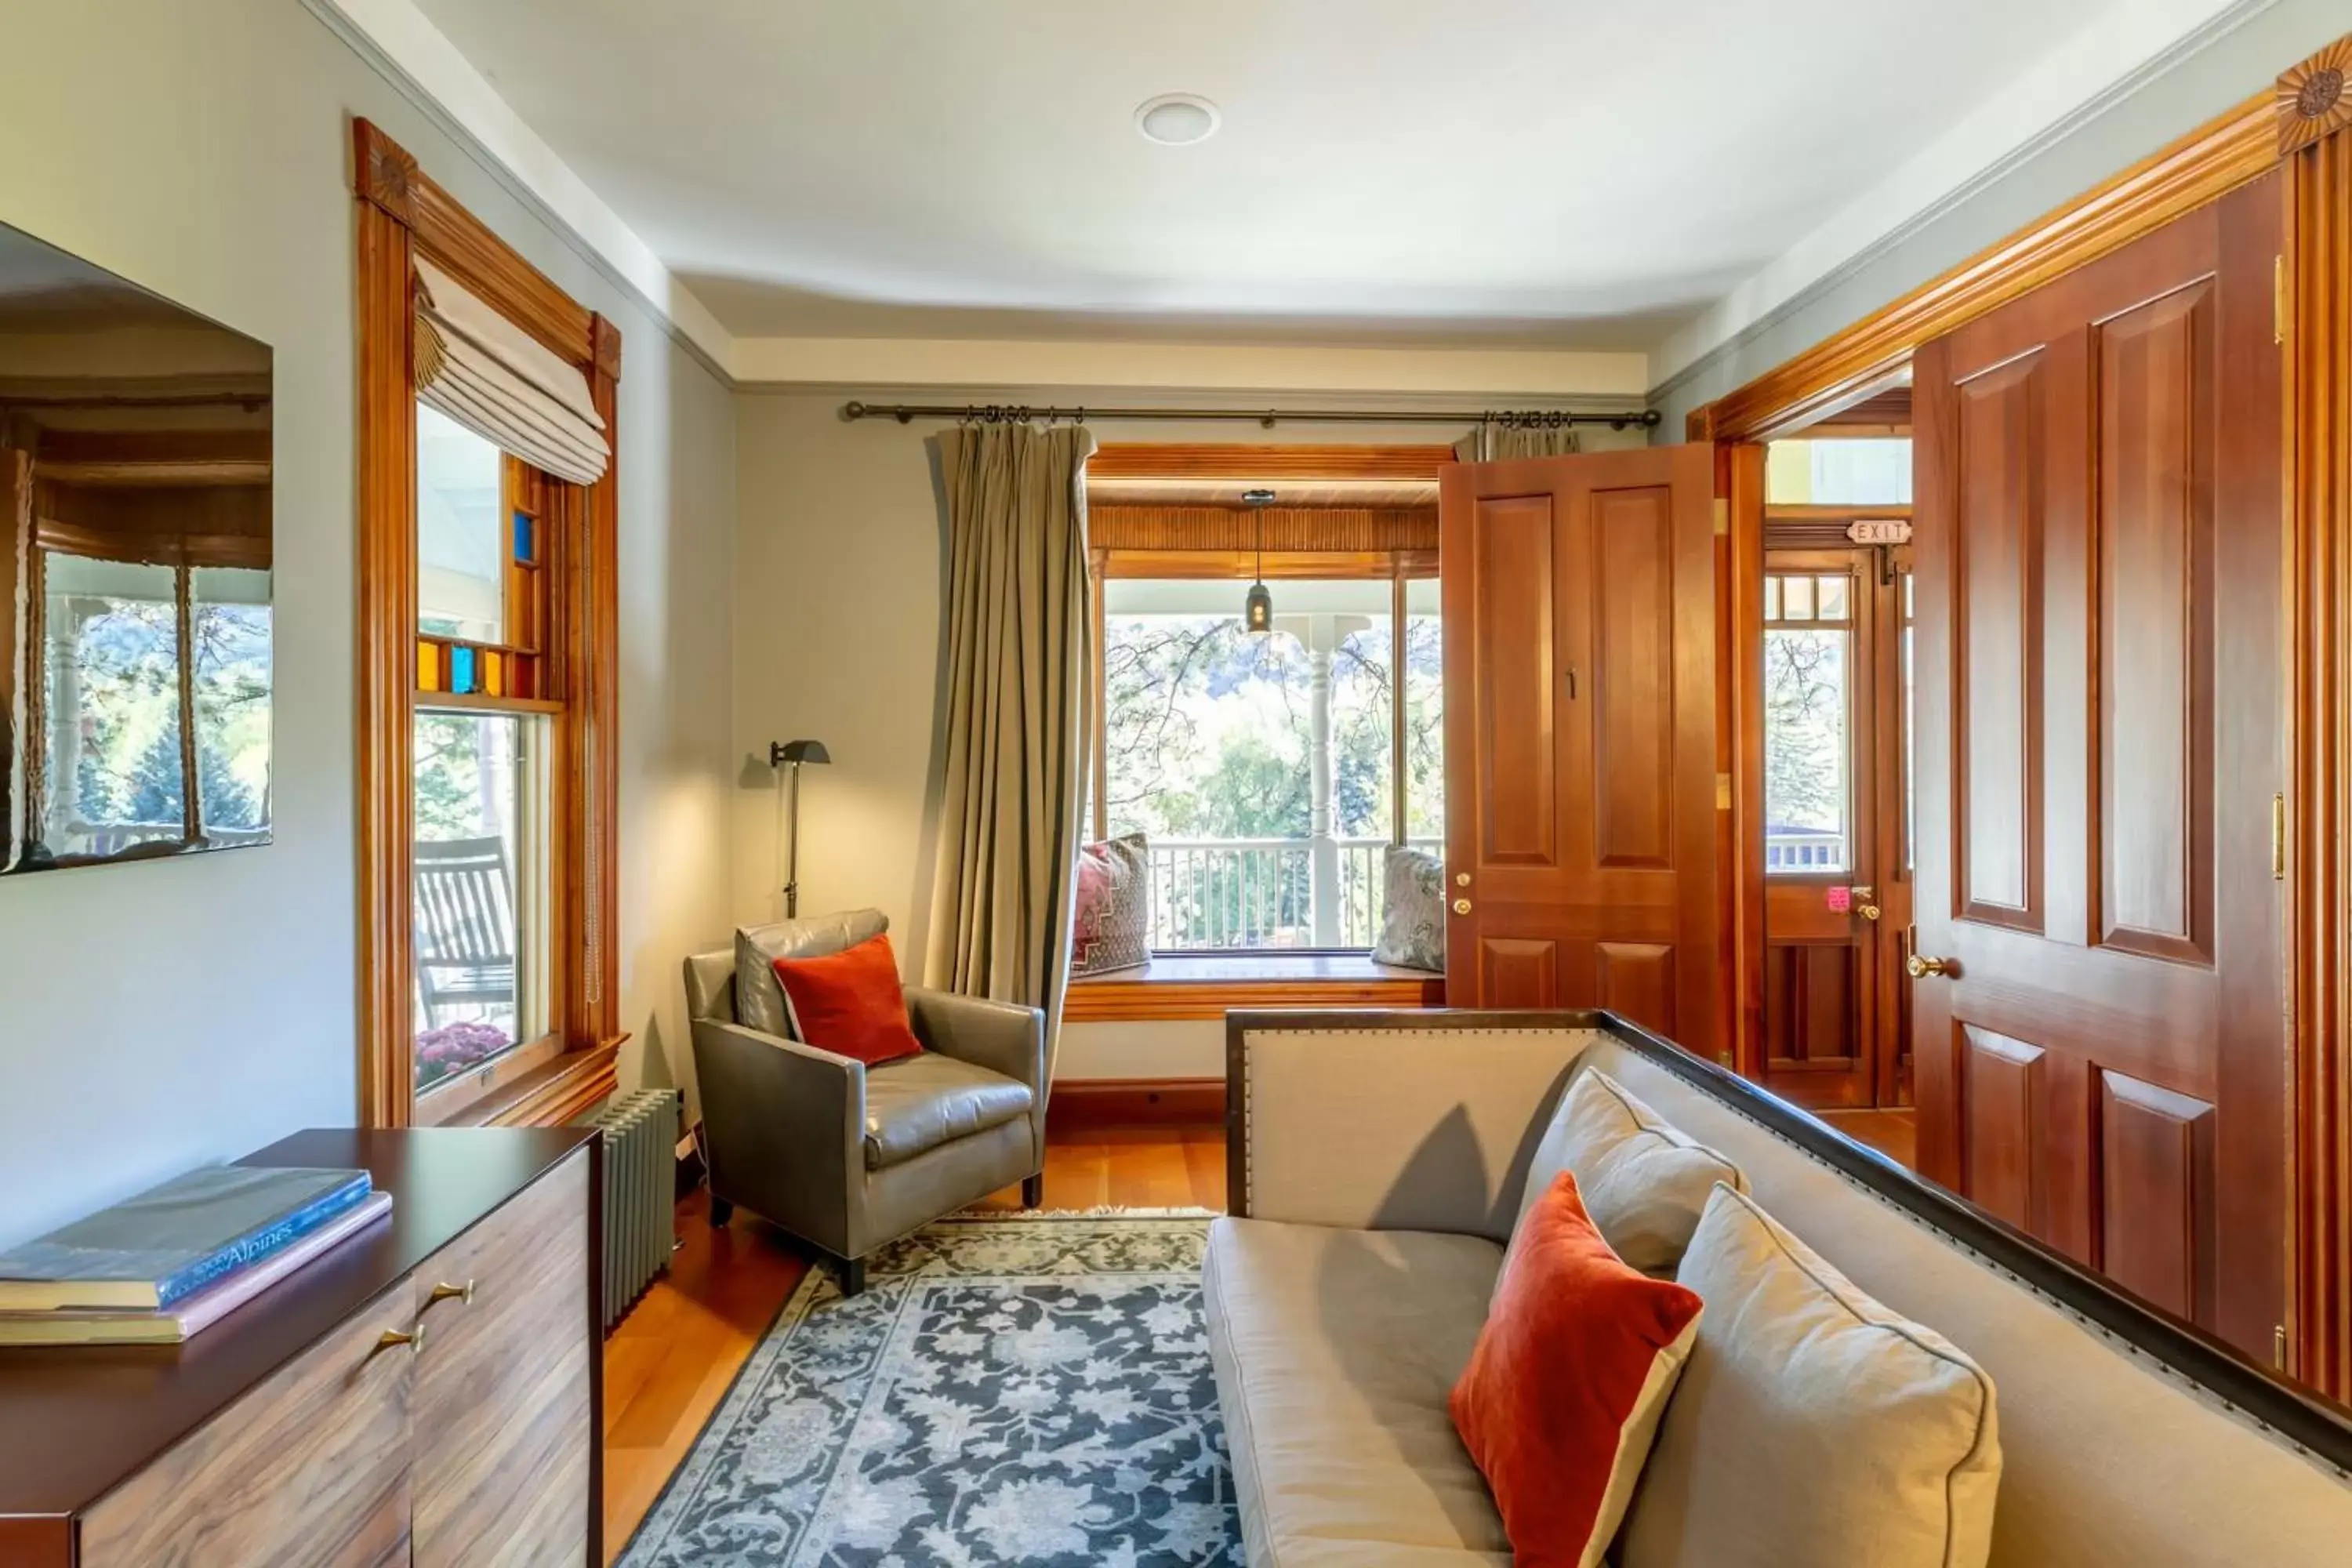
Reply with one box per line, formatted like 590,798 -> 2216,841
355,120 -> 621,1126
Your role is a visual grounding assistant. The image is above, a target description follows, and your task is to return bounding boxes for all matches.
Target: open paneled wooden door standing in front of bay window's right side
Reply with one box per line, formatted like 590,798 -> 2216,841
1439,447 -> 1726,1055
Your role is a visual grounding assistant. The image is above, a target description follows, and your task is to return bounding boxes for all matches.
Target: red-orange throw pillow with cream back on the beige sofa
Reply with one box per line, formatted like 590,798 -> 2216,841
1451,1171 -> 1700,1568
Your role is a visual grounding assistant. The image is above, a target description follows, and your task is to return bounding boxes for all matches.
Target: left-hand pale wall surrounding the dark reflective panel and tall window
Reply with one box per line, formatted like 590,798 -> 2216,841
0,0 -> 736,1246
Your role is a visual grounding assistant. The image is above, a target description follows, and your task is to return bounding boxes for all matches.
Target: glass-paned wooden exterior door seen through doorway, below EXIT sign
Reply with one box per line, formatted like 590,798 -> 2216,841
1764,548 -> 1882,1109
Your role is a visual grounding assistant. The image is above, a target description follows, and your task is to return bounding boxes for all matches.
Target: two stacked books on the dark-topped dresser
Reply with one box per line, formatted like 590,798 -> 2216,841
0,1166 -> 393,1345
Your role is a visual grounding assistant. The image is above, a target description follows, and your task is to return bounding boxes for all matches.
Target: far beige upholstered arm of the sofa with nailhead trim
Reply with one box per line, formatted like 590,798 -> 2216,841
1225,1011 -> 1595,1241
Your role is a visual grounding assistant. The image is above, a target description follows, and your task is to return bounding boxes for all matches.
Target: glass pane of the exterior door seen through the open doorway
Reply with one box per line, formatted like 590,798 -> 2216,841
1764,572 -> 1856,874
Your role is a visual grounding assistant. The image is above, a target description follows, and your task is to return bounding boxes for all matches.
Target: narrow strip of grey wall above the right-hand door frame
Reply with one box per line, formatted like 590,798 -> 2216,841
1651,0 -> 2352,433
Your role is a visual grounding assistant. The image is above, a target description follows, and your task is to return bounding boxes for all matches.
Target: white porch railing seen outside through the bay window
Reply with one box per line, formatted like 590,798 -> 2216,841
1150,839 -> 1439,952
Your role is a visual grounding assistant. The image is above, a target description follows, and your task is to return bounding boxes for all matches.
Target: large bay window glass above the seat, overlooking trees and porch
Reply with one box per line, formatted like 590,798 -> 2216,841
1096,576 -> 1444,952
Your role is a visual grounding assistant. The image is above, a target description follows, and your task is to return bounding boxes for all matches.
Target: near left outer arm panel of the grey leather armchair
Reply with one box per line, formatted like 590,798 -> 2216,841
694,1018 -> 866,1255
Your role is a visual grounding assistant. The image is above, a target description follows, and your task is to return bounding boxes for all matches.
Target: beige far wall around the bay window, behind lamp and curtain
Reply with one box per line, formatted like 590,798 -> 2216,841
734,388 -> 1642,1076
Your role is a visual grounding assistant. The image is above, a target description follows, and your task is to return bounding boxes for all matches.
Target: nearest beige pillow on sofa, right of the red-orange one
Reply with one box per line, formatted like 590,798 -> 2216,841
1621,1187 -> 2002,1568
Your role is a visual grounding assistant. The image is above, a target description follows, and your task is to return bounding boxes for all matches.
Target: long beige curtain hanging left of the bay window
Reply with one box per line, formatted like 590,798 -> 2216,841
924,426 -> 1094,1081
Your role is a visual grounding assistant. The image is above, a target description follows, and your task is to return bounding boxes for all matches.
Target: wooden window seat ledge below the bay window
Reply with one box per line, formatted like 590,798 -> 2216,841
1063,952 -> 1446,1022
